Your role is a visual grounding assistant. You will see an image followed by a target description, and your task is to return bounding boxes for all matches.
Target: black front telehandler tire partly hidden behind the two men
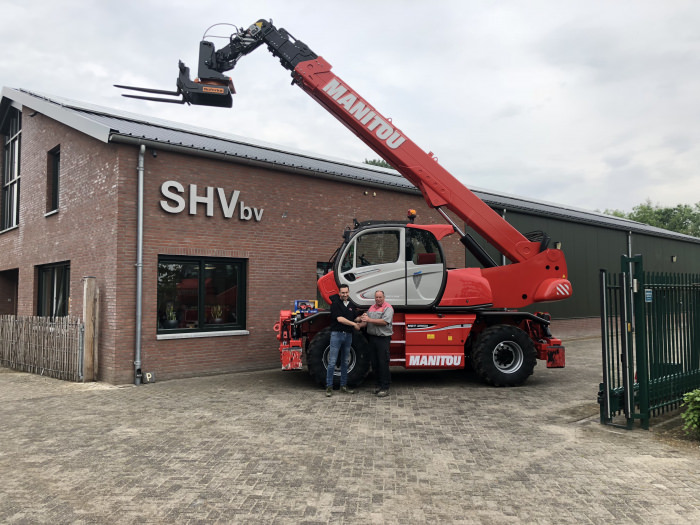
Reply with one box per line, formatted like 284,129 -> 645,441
306,328 -> 370,387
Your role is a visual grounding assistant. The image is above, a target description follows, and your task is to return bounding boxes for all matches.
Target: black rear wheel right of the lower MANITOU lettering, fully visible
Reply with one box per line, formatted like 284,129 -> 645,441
472,324 -> 537,386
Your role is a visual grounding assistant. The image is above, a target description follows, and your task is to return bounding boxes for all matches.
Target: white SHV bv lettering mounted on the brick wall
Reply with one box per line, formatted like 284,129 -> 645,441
160,180 -> 265,222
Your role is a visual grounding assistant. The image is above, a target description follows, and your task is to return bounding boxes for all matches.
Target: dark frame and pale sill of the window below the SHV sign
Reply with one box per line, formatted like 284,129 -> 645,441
156,254 -> 248,336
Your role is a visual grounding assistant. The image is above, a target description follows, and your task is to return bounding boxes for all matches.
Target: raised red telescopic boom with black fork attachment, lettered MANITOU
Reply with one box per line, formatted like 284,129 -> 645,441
119,20 -> 563,267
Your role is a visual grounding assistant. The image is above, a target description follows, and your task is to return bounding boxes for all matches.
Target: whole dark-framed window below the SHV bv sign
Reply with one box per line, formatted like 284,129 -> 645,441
158,255 -> 246,333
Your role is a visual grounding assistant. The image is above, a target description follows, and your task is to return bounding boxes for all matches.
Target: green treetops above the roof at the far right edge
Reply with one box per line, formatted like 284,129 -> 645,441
605,199 -> 700,237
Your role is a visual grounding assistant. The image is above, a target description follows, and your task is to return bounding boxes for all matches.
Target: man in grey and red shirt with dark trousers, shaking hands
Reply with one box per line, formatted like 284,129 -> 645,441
360,290 -> 394,397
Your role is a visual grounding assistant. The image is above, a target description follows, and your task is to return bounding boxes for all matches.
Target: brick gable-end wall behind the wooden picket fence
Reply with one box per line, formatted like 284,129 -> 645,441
0,112 -> 118,370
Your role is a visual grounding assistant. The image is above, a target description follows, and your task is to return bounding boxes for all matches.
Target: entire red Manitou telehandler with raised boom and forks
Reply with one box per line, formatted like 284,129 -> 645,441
117,20 -> 572,386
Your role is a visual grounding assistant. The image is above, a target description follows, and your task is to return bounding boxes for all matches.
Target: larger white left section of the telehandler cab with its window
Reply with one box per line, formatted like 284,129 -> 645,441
337,227 -> 406,306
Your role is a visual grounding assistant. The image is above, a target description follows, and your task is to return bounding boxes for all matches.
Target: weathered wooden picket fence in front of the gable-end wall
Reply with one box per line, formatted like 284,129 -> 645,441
0,315 -> 84,381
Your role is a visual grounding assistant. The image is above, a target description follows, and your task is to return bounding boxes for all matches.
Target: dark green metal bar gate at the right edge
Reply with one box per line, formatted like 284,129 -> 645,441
598,255 -> 700,429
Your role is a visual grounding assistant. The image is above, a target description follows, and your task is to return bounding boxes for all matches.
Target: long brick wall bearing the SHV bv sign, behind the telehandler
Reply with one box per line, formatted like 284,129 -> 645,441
114,146 -> 464,382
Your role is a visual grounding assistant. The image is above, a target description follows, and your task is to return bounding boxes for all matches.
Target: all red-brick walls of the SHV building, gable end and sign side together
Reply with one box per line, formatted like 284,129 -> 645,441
5,106 -> 592,383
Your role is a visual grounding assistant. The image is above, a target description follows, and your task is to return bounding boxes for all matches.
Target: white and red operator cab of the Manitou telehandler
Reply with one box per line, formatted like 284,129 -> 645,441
334,223 -> 454,307
